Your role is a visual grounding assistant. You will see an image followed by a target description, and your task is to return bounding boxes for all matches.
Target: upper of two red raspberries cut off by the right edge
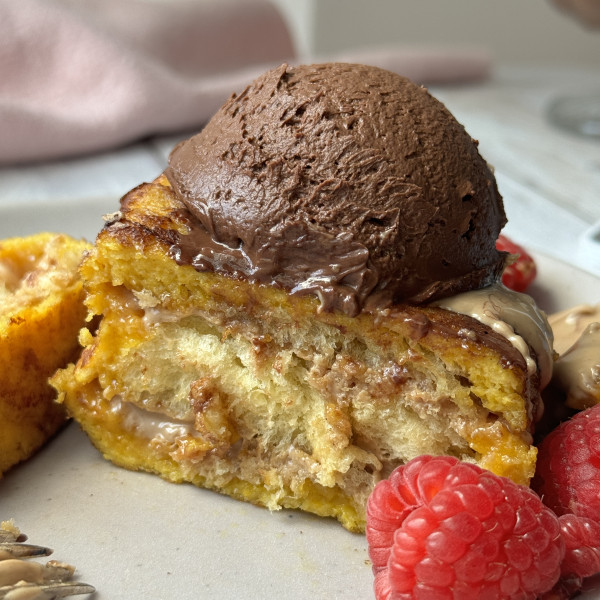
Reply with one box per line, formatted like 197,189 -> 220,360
531,405 -> 600,520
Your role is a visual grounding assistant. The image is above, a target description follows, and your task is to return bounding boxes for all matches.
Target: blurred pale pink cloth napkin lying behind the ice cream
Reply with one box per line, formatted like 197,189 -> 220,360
0,0 -> 489,164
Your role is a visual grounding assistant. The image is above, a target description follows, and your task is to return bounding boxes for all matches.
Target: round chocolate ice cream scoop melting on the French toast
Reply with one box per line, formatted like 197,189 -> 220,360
166,63 -> 506,315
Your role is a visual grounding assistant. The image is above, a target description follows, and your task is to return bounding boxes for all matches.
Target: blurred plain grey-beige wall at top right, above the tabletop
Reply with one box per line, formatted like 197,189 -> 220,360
274,0 -> 600,66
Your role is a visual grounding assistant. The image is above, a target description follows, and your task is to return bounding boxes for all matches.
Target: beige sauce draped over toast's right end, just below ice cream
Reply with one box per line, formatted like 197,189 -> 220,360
433,283 -> 553,388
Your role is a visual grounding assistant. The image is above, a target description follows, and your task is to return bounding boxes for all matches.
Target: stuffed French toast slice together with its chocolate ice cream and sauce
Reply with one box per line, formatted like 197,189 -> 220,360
52,63 -> 552,531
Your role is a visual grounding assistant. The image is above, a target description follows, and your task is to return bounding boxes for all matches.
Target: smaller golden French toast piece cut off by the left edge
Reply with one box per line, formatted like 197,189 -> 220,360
0,233 -> 89,475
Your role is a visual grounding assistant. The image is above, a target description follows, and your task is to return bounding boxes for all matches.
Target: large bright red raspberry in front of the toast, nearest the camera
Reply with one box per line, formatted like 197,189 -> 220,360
366,456 -> 564,600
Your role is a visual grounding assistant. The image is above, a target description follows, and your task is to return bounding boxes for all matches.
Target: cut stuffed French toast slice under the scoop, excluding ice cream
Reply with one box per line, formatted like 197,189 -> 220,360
52,176 -> 539,531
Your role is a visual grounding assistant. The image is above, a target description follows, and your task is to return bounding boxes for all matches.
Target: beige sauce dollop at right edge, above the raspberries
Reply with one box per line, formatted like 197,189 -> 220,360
548,304 -> 600,409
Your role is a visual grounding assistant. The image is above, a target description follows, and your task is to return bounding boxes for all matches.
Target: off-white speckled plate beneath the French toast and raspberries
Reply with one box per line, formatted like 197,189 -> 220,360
0,200 -> 600,600
